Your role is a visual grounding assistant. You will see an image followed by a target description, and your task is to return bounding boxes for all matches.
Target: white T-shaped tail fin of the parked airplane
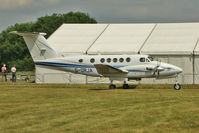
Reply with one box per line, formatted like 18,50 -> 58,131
10,31 -> 57,61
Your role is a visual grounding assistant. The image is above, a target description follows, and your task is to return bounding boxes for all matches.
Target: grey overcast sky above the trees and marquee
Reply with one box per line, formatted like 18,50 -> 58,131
0,0 -> 199,31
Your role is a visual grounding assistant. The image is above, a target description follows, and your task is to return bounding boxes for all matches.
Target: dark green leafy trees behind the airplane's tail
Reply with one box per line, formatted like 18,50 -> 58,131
0,12 -> 97,71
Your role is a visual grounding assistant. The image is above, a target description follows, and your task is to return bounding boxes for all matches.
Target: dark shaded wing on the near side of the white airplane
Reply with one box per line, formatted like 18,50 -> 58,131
94,64 -> 128,76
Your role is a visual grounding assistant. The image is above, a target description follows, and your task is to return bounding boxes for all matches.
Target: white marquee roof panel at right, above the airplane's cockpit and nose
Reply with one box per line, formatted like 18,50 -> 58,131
141,23 -> 199,55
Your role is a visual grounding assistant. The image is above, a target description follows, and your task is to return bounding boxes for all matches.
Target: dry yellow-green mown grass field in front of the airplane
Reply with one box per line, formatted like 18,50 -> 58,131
0,84 -> 199,133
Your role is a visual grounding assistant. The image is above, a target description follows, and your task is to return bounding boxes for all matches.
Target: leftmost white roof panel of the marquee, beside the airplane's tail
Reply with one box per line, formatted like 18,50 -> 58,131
48,24 -> 107,53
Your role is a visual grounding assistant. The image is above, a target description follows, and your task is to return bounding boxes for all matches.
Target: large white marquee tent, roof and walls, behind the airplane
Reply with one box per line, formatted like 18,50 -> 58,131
36,23 -> 199,84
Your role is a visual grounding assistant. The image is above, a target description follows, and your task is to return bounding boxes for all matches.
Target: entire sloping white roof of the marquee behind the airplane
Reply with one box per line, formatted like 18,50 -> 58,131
48,23 -> 199,55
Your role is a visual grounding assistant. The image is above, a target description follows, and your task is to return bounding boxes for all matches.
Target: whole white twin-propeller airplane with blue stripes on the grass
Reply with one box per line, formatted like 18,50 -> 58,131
10,31 -> 182,90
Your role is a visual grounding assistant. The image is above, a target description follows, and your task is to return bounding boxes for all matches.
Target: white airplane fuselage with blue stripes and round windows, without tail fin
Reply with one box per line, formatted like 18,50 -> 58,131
35,55 -> 182,80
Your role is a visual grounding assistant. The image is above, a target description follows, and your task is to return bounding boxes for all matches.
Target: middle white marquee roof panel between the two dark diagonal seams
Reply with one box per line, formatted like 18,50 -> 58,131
88,24 -> 155,54
